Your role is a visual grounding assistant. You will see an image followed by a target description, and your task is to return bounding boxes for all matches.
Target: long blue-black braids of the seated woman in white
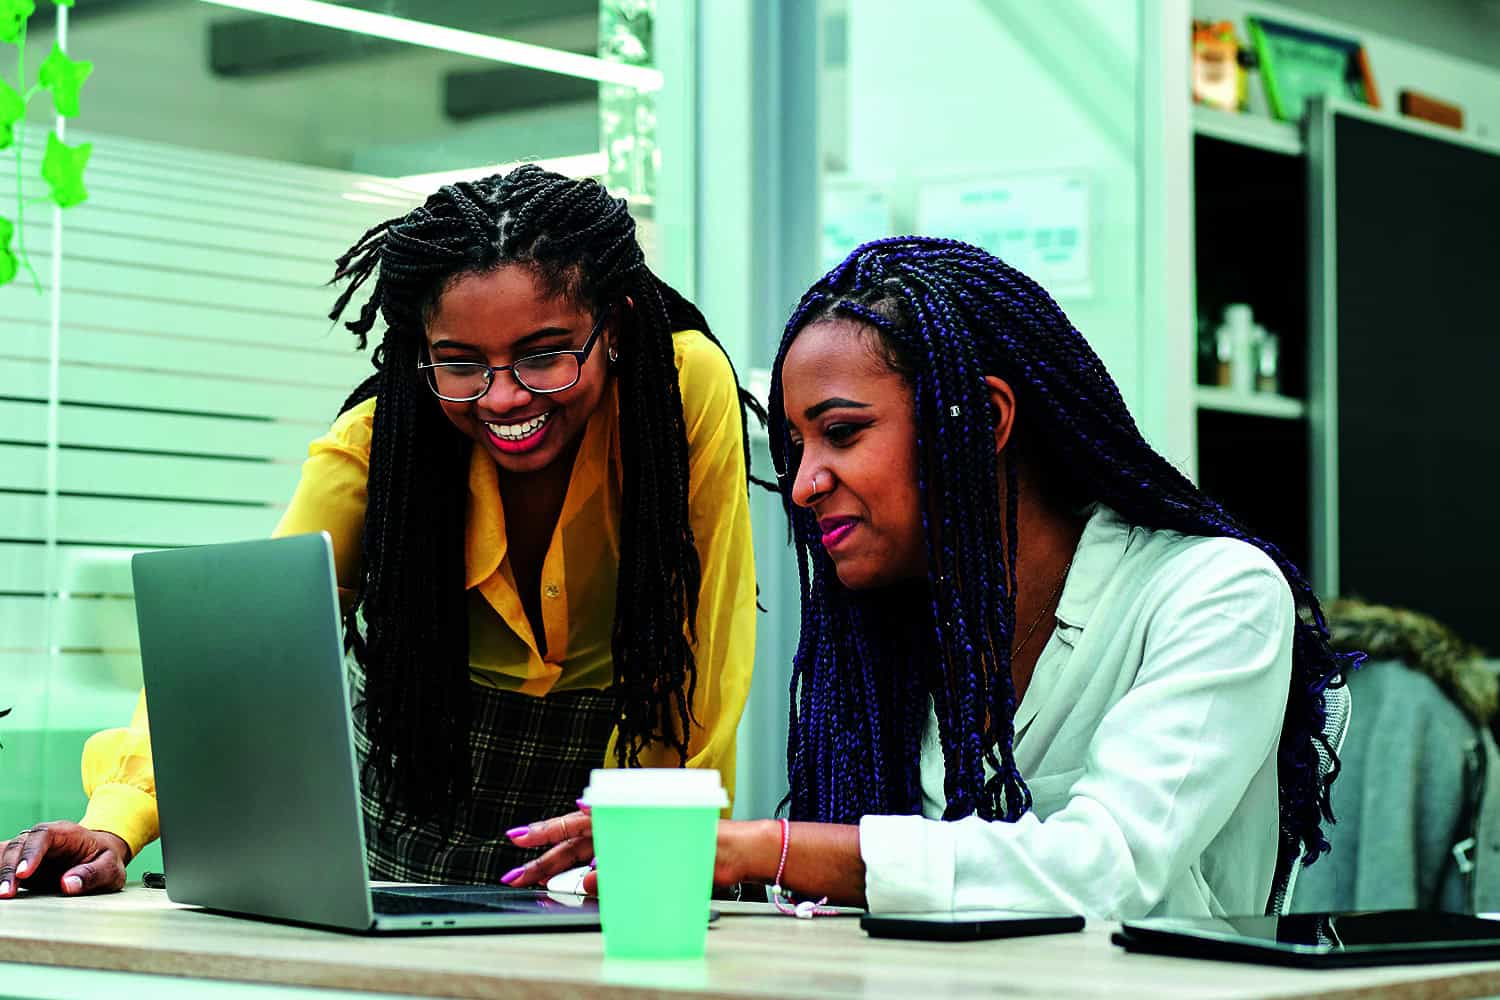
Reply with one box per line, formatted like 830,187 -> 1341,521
770,237 -> 1358,877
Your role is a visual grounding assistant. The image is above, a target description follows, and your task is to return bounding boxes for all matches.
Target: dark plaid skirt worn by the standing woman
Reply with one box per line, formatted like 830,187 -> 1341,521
351,673 -> 620,885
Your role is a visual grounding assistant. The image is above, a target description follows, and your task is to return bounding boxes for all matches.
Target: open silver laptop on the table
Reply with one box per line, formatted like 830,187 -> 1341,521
132,532 -> 599,934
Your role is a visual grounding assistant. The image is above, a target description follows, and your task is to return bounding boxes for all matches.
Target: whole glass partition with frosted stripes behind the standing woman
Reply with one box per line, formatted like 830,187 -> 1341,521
0,0 -> 692,874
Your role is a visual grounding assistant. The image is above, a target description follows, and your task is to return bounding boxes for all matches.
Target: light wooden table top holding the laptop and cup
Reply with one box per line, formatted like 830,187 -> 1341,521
0,886 -> 1500,1000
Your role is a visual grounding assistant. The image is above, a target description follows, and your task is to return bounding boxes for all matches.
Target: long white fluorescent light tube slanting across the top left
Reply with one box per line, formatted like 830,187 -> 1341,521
204,0 -> 662,90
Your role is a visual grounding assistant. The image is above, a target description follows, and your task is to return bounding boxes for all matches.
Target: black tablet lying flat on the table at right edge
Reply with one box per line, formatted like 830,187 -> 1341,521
1113,910 -> 1500,969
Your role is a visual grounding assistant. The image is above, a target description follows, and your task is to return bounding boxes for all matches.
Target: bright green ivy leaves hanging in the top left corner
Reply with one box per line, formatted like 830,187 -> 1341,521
0,0 -> 93,290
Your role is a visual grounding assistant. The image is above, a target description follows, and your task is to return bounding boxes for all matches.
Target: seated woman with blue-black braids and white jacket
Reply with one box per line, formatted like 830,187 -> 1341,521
702,237 -> 1352,918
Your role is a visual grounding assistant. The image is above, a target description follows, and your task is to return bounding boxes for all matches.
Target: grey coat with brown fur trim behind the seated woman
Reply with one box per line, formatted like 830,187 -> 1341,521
1292,600 -> 1500,912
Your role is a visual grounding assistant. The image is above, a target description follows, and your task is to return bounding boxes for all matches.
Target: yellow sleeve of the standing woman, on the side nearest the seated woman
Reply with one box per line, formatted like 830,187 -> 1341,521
630,333 -> 756,816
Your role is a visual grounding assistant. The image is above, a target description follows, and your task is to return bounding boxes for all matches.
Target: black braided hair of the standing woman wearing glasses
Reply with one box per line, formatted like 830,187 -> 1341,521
330,165 -> 765,817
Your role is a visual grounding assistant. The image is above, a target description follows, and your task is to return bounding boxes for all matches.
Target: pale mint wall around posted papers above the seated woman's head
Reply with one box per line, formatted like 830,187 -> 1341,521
825,0 -> 1142,419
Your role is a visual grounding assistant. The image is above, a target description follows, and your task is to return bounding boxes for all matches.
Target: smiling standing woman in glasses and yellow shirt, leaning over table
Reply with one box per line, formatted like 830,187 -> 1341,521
0,165 -> 764,898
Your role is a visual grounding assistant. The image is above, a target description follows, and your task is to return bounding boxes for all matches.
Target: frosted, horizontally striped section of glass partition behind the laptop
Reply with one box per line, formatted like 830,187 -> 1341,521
0,127 -> 413,828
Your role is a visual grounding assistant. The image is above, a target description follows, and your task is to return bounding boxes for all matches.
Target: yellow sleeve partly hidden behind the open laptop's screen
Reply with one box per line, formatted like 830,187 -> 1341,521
83,400 -> 375,858
